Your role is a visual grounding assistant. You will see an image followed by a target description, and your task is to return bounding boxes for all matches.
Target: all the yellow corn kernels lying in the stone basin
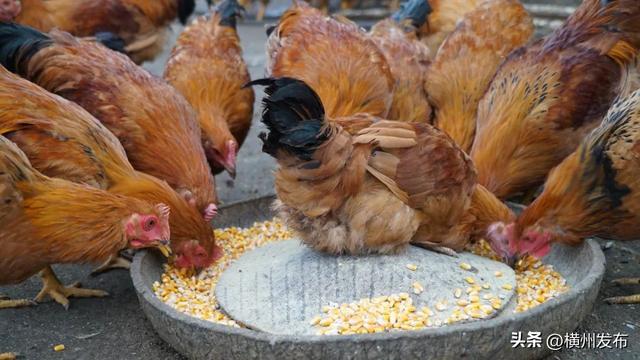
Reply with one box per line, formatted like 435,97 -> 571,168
153,218 -> 568,335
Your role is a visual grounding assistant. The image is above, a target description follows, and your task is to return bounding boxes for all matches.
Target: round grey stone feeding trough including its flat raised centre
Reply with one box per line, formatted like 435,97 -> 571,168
131,198 -> 604,360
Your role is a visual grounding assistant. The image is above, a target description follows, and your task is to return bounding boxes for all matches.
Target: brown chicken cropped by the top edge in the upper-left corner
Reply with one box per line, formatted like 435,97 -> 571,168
0,0 -> 195,63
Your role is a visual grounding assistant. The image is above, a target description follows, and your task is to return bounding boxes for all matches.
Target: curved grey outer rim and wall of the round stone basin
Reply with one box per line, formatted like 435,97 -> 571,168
131,198 -> 604,360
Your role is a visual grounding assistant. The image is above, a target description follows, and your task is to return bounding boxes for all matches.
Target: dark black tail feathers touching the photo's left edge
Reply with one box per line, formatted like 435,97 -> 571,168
0,22 -> 53,74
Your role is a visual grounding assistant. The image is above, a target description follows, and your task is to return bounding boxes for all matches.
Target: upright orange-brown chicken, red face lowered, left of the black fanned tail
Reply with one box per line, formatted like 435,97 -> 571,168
164,0 -> 254,177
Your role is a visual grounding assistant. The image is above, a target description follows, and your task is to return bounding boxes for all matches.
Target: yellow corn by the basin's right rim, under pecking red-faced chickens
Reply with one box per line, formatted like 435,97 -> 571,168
468,240 -> 569,312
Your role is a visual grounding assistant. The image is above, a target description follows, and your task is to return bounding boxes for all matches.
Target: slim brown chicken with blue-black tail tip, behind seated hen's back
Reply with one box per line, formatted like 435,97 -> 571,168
369,0 -> 431,122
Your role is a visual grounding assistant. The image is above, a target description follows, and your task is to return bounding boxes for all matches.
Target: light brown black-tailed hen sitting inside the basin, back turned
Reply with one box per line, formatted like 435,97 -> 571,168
253,78 -> 513,254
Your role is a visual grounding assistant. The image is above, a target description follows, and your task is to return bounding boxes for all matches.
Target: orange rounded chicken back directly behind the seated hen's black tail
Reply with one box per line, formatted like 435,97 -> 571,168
267,1 -> 394,117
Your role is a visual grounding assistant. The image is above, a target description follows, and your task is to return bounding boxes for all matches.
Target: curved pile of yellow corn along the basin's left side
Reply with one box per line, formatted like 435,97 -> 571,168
153,219 -> 291,327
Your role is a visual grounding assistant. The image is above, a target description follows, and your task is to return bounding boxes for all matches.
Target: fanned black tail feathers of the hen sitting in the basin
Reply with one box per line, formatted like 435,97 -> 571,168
246,78 -> 327,161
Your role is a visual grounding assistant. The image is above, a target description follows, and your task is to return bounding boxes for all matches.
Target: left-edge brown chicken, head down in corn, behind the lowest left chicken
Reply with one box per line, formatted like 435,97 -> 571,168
0,66 -> 221,268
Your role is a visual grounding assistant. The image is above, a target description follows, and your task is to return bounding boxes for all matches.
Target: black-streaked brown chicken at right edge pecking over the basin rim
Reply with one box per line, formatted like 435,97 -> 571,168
492,90 -> 640,303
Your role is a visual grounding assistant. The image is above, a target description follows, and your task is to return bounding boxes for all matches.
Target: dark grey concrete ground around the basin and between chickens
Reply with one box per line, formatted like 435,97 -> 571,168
0,2 -> 640,360
